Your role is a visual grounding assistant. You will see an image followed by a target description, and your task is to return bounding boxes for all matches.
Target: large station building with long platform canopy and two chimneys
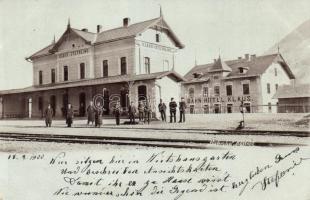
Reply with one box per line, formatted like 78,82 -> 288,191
0,15 -> 184,118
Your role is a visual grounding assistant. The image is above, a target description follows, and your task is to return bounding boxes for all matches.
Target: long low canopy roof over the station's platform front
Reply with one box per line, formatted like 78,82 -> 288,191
0,71 -> 185,95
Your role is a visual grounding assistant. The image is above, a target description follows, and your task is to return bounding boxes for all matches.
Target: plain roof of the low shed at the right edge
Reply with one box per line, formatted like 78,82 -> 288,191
273,84 -> 310,99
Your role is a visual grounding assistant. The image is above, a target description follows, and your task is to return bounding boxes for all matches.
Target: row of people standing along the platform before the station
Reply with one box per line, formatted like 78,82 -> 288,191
44,97 -> 186,127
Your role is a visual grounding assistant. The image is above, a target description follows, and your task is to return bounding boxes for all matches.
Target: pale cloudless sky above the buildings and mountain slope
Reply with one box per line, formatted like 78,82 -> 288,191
0,0 -> 310,90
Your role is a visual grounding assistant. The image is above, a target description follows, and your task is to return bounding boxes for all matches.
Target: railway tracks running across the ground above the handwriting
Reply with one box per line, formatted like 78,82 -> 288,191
0,127 -> 310,149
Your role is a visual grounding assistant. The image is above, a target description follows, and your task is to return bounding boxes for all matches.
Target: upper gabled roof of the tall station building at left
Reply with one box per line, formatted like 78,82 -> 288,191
27,17 -> 184,59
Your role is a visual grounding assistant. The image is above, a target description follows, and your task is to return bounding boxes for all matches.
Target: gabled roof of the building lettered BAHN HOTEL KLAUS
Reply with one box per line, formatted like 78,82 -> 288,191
184,54 -> 295,81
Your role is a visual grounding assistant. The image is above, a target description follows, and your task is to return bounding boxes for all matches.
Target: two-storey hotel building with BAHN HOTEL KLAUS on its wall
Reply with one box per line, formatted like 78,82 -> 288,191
181,53 -> 295,114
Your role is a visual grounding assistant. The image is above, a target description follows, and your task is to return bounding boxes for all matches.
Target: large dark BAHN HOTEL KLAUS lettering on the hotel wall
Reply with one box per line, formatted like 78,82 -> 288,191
187,95 -> 252,104
